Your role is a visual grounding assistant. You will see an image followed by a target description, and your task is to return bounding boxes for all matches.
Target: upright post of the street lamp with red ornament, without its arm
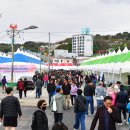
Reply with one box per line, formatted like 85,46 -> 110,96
11,29 -> 15,83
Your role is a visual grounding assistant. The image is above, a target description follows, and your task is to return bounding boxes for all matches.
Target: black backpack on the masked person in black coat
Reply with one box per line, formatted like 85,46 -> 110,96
31,110 -> 43,130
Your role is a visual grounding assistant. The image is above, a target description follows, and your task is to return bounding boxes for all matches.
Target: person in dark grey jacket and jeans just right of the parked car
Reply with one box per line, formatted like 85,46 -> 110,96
36,76 -> 42,98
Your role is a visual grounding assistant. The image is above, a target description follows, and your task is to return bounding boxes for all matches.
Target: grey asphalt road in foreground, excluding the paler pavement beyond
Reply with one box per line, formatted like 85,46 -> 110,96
0,107 -> 128,130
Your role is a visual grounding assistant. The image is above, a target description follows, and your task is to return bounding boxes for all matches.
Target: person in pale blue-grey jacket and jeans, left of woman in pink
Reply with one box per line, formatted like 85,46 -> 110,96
95,82 -> 106,108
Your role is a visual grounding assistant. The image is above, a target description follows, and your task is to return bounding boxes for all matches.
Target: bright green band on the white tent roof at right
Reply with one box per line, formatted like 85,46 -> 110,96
81,52 -> 130,66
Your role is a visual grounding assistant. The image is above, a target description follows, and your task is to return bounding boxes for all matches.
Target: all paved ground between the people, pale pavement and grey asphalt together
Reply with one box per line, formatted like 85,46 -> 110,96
0,88 -> 128,130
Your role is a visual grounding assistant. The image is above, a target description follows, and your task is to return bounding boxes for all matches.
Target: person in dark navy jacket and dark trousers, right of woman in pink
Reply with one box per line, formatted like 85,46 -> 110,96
115,85 -> 128,125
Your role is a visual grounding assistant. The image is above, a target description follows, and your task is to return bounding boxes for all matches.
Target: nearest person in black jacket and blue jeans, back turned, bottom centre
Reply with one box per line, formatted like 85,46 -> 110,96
74,89 -> 86,130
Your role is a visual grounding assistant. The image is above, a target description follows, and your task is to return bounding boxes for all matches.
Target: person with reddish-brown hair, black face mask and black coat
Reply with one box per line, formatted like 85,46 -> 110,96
33,100 -> 49,130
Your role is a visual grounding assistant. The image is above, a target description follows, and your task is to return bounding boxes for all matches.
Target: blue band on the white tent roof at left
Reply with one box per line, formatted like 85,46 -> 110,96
0,53 -> 41,64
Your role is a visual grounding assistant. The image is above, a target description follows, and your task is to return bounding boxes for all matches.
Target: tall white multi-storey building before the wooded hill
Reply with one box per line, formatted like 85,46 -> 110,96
72,34 -> 93,57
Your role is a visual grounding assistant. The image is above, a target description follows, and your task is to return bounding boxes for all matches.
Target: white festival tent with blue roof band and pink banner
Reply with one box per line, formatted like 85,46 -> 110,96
0,49 -> 46,82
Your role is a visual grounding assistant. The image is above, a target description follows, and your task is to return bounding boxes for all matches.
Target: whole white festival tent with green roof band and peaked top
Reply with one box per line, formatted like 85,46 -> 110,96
78,47 -> 130,82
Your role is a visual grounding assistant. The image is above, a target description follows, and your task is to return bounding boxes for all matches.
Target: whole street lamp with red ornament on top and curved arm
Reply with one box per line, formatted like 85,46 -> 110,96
7,24 -> 38,83
